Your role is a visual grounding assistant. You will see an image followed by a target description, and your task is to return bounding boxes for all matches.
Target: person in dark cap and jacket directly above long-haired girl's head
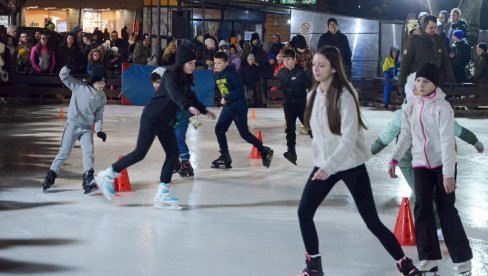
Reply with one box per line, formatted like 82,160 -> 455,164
317,17 -> 352,79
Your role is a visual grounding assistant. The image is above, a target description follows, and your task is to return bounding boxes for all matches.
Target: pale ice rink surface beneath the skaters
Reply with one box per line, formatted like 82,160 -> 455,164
0,104 -> 488,276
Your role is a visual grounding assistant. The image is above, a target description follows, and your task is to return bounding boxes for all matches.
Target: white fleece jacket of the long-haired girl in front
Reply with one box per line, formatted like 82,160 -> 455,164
309,87 -> 371,175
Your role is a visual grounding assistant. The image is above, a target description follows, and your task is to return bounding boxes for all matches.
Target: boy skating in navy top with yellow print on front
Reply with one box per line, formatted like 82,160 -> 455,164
212,52 -> 273,169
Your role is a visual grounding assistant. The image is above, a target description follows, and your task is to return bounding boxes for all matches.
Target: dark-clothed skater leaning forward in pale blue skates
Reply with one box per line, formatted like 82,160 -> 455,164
96,45 -> 215,209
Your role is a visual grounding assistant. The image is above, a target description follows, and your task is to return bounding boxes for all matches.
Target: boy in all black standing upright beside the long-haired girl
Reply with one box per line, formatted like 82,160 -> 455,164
278,49 -> 312,165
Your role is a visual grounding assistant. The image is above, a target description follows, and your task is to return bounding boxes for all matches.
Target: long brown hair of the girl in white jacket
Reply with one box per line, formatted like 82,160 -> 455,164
304,46 -> 367,135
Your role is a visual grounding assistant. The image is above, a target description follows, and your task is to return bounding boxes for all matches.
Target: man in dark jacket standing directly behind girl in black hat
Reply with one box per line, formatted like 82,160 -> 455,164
398,15 -> 456,95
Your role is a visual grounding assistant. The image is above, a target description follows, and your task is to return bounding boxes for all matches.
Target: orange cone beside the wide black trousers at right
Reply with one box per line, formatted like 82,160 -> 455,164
395,197 -> 416,245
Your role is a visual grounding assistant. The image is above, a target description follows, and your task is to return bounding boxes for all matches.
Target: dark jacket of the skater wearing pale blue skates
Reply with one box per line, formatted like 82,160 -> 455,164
141,70 -> 207,125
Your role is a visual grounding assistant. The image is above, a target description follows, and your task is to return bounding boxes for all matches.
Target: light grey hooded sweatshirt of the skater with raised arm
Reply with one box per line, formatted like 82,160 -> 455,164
59,66 -> 107,133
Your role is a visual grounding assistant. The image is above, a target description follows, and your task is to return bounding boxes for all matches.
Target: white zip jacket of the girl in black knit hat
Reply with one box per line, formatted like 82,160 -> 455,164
392,88 -> 456,177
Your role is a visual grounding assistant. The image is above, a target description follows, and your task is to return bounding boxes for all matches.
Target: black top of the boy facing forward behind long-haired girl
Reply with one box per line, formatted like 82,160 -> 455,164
278,65 -> 312,105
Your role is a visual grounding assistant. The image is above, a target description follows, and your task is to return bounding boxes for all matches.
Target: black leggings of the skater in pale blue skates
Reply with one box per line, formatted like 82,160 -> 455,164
112,117 -> 179,183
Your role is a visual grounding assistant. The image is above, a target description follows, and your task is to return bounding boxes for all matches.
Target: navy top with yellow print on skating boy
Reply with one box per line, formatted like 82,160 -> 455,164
214,66 -> 247,111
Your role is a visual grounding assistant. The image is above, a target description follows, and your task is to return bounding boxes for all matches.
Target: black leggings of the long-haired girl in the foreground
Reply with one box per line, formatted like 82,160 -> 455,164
298,164 -> 405,260
